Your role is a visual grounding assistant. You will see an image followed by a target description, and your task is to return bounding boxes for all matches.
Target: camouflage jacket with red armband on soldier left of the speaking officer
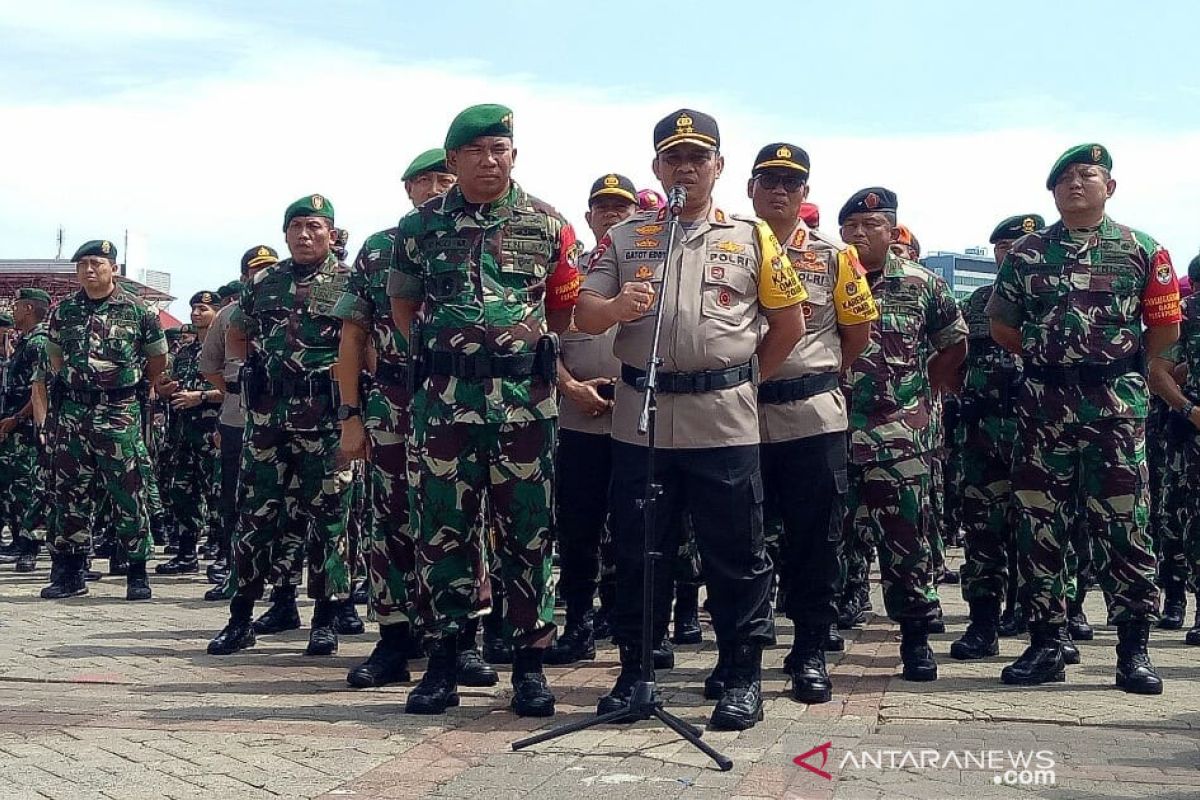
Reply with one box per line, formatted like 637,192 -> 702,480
388,184 -> 580,425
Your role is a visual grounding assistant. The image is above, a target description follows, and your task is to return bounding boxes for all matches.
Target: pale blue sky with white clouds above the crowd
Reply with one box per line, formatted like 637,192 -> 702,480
0,0 -> 1200,308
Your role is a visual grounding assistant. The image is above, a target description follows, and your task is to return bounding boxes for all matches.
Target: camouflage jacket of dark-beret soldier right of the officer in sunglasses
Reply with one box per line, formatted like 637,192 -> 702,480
842,253 -> 967,464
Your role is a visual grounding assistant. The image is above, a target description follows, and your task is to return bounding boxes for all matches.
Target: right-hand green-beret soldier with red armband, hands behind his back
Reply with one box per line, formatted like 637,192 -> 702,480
988,144 -> 1180,694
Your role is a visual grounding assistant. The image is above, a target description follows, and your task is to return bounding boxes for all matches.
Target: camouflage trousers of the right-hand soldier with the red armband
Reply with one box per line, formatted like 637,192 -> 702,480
1013,415 -> 1158,624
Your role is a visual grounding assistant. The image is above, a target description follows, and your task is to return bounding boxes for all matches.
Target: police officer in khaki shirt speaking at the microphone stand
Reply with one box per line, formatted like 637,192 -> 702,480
575,109 -> 806,729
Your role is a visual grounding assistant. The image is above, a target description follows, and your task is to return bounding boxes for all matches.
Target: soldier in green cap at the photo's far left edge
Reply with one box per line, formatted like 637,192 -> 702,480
0,289 -> 50,572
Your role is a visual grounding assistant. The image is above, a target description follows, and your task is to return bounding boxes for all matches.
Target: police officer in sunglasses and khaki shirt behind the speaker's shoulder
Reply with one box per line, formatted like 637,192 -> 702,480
746,143 -> 878,703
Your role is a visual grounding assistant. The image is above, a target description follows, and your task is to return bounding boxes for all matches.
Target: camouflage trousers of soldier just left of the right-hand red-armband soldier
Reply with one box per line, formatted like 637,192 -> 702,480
958,414 -> 1016,602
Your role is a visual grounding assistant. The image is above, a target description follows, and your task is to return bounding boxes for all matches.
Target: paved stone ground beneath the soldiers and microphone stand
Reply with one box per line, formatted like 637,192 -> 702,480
0,551 -> 1200,800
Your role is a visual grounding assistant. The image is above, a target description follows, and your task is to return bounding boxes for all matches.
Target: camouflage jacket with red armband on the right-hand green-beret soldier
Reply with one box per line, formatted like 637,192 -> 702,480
988,217 -> 1180,422
